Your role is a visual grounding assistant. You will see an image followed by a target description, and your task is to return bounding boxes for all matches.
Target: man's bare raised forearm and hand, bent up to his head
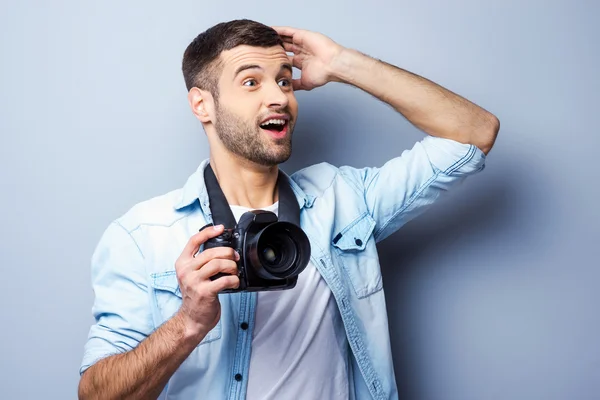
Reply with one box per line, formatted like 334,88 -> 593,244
274,27 -> 500,154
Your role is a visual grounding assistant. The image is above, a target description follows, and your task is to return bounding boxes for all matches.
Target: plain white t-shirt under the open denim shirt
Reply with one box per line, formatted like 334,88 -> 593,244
231,202 -> 349,400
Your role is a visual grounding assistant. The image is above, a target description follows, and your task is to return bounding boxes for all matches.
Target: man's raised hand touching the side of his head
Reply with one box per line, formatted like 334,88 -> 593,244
272,26 -> 344,90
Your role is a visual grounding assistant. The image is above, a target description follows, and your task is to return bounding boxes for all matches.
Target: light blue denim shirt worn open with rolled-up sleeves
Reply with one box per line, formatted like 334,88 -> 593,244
80,136 -> 485,399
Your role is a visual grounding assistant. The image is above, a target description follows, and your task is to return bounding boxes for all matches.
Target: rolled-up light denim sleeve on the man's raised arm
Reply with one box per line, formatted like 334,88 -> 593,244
340,136 -> 486,241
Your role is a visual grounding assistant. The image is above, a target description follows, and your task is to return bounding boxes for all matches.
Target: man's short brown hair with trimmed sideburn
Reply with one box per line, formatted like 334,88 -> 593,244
181,19 -> 283,98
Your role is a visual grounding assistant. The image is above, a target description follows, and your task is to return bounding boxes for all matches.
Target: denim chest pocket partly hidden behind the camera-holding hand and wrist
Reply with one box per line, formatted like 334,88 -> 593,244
150,270 -> 222,346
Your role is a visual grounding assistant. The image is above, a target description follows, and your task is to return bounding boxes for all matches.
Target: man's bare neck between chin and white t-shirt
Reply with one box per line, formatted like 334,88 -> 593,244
210,154 -> 279,209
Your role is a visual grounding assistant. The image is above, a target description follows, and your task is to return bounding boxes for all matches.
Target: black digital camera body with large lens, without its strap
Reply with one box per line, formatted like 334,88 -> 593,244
201,210 -> 310,293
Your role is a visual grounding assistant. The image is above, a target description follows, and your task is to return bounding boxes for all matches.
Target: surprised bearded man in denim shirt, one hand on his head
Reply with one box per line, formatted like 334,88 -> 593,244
79,20 -> 499,399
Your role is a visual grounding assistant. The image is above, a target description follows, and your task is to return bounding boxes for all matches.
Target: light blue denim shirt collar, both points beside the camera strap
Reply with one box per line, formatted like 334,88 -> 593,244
173,158 -> 315,215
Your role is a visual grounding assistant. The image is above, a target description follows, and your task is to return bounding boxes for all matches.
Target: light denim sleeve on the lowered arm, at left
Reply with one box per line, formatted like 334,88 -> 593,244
79,222 -> 153,374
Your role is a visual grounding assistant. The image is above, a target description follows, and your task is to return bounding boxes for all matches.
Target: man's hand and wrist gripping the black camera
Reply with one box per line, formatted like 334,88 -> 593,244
175,225 -> 240,340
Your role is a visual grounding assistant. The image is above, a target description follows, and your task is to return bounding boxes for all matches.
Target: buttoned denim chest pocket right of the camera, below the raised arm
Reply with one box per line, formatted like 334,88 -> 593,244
332,213 -> 383,299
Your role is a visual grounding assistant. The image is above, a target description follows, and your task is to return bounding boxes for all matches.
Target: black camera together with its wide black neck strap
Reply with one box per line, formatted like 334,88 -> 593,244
200,164 -> 310,293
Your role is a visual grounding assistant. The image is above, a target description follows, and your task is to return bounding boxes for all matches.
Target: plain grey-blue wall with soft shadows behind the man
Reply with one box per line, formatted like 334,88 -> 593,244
0,0 -> 600,400
